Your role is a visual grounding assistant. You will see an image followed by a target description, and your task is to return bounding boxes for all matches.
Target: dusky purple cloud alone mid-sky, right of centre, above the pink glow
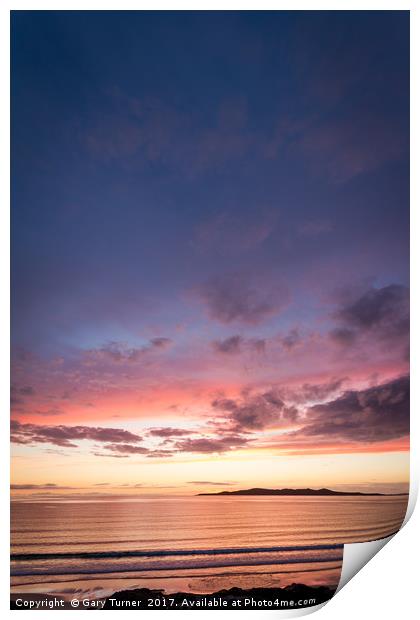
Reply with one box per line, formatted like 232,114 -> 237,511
197,274 -> 289,325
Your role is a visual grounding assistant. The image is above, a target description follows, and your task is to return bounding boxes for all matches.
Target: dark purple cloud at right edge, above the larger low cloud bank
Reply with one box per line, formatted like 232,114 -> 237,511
330,284 -> 409,345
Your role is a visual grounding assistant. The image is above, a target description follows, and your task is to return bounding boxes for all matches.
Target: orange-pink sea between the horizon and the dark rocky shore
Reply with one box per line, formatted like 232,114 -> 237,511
11,496 -> 408,597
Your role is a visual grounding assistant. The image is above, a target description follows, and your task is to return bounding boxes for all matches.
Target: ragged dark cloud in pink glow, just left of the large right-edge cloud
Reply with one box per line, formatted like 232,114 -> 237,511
212,388 -> 298,431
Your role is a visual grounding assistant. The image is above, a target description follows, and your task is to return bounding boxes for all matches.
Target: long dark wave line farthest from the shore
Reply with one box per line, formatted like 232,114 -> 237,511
10,544 -> 343,561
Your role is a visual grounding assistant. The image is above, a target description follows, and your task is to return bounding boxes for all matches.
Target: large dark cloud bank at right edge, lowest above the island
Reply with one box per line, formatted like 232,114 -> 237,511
296,377 -> 410,442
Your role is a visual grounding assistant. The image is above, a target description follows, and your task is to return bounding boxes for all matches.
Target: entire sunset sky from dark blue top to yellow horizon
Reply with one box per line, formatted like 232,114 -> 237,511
11,11 -> 409,497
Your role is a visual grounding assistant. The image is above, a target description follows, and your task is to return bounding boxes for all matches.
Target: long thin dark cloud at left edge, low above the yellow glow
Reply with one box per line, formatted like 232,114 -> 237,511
11,420 -> 142,448
